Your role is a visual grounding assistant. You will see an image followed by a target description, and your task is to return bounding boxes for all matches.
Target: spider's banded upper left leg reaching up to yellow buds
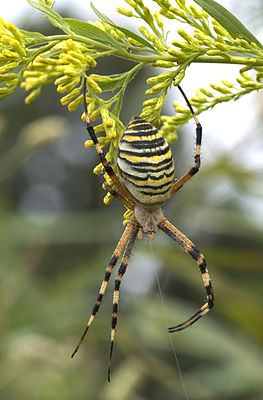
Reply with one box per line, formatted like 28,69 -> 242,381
83,78 -> 131,200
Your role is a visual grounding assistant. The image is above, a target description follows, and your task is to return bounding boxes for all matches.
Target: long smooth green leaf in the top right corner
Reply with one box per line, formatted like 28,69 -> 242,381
194,0 -> 263,49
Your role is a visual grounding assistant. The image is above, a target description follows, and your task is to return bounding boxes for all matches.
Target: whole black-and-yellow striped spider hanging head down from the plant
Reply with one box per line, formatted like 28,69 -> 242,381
71,80 -> 214,381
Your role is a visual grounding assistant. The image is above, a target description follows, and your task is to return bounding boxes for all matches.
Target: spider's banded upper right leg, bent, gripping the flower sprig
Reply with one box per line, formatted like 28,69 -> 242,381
170,85 -> 202,197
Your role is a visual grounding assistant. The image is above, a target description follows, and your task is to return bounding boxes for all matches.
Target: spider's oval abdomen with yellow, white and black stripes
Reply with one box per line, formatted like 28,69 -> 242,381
117,117 -> 174,205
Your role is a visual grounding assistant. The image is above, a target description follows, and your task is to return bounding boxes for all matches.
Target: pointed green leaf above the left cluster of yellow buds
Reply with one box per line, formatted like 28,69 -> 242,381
63,18 -> 122,50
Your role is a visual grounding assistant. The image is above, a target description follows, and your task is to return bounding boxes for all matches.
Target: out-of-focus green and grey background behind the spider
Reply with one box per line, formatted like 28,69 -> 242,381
0,0 -> 263,400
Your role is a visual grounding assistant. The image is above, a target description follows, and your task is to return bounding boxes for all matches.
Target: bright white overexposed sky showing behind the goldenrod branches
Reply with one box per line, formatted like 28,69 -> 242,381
0,0 -> 263,167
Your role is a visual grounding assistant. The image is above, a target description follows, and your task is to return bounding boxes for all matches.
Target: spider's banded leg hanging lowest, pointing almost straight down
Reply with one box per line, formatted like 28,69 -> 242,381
108,224 -> 140,382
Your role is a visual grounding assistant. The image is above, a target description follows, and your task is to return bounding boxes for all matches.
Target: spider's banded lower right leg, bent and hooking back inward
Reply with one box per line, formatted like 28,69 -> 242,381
158,218 -> 214,333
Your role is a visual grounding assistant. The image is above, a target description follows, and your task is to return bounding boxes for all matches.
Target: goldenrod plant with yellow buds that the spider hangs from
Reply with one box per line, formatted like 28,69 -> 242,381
0,0 -> 263,213
